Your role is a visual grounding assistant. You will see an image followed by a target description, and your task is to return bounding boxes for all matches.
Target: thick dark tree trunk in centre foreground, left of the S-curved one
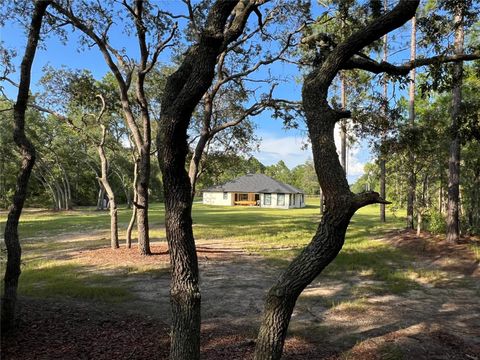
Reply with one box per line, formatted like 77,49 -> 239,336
157,0 -> 259,360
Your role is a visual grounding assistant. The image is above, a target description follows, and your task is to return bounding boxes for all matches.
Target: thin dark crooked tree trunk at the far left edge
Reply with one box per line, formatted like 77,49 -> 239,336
1,1 -> 50,332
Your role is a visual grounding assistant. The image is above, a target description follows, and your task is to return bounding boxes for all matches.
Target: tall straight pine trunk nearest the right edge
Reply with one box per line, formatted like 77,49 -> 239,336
447,9 -> 464,243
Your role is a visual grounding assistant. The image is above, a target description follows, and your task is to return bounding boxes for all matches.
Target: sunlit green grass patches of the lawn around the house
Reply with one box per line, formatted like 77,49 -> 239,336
0,200 -> 433,302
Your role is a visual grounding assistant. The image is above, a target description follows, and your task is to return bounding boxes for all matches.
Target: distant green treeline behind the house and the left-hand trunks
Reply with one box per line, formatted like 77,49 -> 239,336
0,104 -> 320,210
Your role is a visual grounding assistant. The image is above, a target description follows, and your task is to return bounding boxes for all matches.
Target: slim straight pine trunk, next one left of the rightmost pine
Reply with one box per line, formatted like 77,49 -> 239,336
407,16 -> 417,229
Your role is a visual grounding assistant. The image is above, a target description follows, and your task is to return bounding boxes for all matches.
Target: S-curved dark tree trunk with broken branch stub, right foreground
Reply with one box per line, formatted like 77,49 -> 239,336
254,0 -> 419,360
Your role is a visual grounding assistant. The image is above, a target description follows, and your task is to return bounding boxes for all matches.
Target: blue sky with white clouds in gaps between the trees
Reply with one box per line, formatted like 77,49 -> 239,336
0,1 -> 398,182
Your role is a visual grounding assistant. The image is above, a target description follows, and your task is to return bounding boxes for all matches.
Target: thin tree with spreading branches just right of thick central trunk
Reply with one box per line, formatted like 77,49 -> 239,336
189,6 -> 303,195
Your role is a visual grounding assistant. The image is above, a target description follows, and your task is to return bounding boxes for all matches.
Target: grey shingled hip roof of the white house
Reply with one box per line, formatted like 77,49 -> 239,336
203,174 -> 304,194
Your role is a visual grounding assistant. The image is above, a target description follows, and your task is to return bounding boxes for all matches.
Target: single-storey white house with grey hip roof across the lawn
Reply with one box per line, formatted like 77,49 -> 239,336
203,174 -> 305,209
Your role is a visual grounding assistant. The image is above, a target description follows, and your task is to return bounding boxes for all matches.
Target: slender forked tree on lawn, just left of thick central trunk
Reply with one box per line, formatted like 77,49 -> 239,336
52,0 -> 177,255
